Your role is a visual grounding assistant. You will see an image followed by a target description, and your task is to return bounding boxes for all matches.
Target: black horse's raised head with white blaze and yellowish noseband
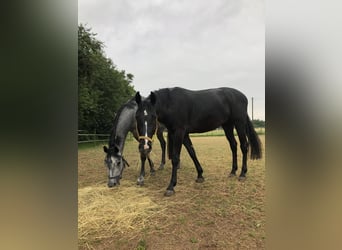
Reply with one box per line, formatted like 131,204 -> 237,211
135,92 -> 157,154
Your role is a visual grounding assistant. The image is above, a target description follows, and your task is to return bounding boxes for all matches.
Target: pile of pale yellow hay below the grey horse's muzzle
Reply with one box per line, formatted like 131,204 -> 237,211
78,185 -> 163,240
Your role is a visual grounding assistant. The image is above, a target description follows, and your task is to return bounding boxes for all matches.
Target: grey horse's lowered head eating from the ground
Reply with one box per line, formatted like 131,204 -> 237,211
103,146 -> 125,187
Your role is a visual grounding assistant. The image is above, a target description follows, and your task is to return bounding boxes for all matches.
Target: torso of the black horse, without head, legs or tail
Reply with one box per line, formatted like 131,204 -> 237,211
156,87 -> 247,132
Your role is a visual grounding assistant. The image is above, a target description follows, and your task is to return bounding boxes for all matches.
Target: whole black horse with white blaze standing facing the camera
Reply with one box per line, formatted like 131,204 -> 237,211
135,87 -> 261,196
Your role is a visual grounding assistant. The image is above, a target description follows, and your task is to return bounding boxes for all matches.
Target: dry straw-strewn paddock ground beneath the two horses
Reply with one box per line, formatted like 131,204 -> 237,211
78,135 -> 266,250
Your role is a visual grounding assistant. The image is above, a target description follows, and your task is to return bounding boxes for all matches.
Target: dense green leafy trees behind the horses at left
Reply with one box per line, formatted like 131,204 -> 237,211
78,24 -> 135,133
